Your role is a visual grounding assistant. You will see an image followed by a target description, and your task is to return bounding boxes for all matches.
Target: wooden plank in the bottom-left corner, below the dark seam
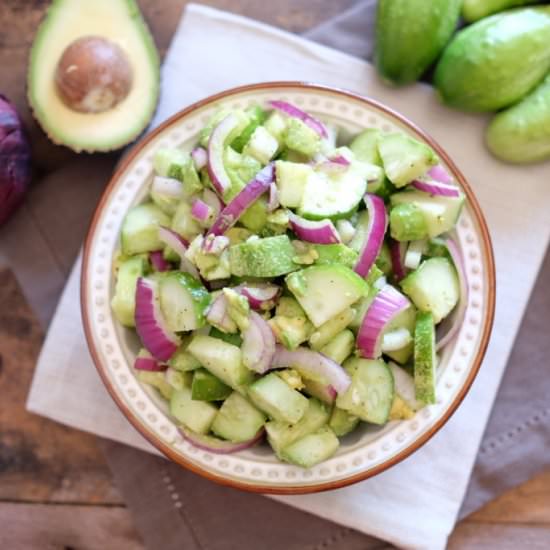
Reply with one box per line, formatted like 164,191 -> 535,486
0,503 -> 144,550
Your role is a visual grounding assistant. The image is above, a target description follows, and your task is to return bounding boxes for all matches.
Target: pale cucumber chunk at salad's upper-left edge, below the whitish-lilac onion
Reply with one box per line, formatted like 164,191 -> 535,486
120,202 -> 170,256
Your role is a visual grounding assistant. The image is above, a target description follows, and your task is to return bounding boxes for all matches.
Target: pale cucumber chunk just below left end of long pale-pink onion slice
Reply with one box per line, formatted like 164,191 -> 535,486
248,372 -> 308,424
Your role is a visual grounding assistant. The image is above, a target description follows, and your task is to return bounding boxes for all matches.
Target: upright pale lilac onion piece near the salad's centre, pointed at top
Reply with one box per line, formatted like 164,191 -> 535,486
241,311 -> 275,374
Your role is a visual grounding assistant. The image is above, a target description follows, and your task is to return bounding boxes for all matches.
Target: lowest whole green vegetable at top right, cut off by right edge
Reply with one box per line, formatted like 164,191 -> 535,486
485,75 -> 550,164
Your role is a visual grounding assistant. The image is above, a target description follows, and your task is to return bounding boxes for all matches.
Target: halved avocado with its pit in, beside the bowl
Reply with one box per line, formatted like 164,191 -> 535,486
27,0 -> 160,152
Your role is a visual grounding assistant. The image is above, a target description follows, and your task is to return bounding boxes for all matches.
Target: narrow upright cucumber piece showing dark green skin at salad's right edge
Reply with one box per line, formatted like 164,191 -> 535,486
414,312 -> 437,405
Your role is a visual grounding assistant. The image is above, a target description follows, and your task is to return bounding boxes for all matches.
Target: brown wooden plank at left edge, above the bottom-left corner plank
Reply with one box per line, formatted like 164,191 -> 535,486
0,269 -> 121,506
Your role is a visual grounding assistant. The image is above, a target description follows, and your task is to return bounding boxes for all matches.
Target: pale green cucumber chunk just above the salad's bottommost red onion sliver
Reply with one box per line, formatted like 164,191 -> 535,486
212,392 -> 266,443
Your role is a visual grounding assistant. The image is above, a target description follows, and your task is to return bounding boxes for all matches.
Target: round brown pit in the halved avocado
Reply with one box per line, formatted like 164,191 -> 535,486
55,36 -> 132,113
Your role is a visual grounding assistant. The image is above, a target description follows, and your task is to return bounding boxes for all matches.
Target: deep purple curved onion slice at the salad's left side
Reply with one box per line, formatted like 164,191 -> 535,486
135,277 -> 179,361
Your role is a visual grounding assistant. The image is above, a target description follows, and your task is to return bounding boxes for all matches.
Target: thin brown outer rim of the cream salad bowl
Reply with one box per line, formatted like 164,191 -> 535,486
80,80 -> 496,495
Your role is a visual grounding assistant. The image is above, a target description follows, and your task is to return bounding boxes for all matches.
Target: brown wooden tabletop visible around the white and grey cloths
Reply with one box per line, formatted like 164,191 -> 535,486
0,0 -> 550,550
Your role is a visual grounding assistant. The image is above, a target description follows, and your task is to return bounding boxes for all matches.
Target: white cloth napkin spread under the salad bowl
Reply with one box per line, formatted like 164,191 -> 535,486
28,4 -> 550,548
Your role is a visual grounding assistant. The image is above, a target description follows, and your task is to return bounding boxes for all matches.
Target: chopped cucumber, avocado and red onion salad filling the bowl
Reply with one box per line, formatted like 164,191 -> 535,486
112,101 -> 467,468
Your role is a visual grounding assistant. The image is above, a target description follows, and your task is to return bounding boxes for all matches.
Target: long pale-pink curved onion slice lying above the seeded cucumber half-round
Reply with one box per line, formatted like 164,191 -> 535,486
271,345 -> 351,394
